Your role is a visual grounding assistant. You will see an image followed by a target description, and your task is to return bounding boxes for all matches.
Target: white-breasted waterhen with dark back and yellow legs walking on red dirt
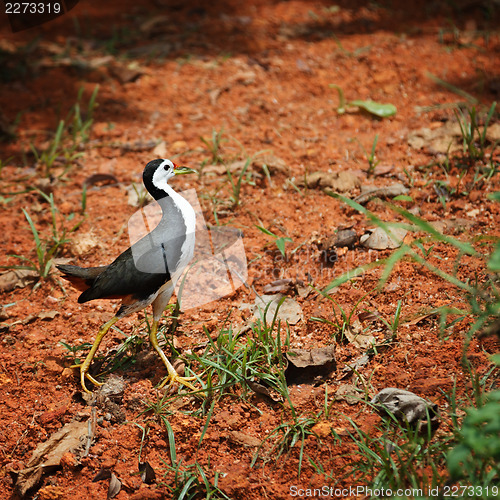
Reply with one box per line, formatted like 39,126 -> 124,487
57,159 -> 196,392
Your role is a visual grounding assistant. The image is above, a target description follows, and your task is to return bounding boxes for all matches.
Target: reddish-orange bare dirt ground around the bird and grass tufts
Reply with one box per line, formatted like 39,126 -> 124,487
0,0 -> 500,500
